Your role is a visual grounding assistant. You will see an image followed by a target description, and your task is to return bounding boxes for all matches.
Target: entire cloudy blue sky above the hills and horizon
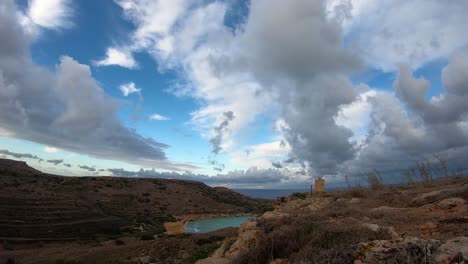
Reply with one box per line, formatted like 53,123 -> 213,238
0,0 -> 468,188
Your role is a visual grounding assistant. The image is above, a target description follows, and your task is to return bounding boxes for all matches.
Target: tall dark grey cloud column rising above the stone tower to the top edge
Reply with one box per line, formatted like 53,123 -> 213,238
236,0 -> 360,175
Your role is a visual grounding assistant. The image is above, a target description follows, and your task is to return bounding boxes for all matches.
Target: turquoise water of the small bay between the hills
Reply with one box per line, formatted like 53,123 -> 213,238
185,216 -> 254,233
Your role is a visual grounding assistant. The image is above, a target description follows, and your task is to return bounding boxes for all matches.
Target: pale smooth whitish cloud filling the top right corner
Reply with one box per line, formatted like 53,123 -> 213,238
328,0 -> 468,71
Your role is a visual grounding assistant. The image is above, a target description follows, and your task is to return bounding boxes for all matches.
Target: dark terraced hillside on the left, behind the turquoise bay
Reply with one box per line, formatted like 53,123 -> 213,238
0,159 -> 268,241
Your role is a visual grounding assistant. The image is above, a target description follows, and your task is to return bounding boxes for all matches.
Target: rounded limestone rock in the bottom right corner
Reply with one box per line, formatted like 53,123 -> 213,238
436,236 -> 468,264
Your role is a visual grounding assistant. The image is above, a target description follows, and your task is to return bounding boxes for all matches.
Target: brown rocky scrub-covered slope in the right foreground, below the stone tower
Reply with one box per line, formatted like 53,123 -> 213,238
197,177 -> 468,264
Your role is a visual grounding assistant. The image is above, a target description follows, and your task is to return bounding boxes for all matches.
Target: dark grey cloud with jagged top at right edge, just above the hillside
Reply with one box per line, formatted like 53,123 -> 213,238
342,51 -> 468,176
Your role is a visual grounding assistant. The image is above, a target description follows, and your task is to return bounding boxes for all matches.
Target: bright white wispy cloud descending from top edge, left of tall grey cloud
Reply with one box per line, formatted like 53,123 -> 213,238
98,0 -> 270,155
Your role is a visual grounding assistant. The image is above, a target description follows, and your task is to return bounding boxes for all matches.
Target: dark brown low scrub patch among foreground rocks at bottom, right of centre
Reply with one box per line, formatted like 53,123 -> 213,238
235,216 -> 390,264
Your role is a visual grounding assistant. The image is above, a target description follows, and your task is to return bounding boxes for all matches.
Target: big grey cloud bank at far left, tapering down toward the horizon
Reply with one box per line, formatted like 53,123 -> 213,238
0,0 -> 195,170
